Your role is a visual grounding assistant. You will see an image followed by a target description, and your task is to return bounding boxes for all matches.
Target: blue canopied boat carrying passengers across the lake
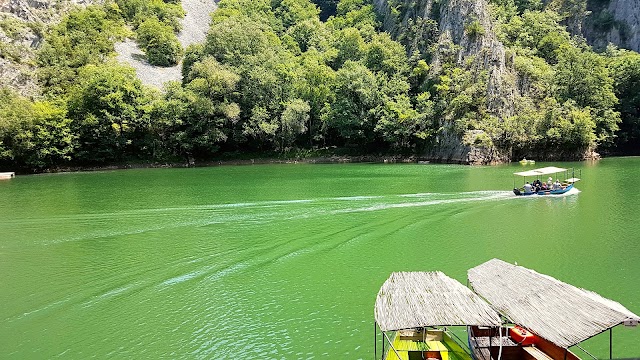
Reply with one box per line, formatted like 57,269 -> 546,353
513,166 -> 580,196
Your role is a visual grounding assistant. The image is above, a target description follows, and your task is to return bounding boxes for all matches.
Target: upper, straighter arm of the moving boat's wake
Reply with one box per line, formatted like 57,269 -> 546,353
5,191 -> 515,245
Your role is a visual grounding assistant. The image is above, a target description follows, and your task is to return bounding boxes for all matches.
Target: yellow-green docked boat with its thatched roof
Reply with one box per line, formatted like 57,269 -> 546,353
374,271 -> 501,360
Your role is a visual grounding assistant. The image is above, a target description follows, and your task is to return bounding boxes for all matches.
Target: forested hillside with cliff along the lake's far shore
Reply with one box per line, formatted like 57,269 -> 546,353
0,0 -> 640,171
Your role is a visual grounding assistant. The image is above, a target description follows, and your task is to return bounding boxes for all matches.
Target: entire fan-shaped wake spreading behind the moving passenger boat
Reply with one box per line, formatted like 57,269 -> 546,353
0,191 -> 515,322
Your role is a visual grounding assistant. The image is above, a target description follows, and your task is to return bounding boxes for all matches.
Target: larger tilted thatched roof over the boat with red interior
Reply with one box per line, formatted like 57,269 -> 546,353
468,259 -> 640,348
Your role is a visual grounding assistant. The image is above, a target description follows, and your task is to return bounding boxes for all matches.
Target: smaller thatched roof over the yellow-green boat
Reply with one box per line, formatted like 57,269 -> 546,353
375,271 -> 500,331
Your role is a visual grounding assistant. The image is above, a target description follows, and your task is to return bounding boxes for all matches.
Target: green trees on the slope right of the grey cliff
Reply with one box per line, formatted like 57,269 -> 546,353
491,0 -> 640,152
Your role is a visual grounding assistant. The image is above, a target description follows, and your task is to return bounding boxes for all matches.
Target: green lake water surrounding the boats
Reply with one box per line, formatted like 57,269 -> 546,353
0,158 -> 640,359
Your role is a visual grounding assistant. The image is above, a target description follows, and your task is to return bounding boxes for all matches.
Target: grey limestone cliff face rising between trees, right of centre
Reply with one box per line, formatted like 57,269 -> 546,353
374,0 -> 518,164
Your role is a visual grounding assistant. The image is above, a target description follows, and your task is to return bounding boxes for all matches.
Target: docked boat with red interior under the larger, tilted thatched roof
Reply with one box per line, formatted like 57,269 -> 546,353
468,259 -> 640,360
